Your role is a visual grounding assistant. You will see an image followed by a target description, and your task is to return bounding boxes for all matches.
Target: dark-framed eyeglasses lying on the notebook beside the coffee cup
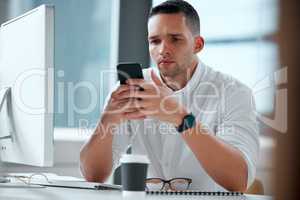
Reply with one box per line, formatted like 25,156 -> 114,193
146,178 -> 192,191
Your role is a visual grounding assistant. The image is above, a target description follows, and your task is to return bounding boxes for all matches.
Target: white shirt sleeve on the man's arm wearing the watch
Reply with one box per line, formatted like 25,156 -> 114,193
216,83 -> 259,188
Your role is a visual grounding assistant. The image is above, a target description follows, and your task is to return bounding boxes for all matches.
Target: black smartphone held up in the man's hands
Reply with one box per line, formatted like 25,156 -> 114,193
117,63 -> 144,84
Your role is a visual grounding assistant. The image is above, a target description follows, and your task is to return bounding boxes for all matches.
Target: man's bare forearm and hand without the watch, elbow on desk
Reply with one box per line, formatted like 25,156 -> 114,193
80,85 -> 145,182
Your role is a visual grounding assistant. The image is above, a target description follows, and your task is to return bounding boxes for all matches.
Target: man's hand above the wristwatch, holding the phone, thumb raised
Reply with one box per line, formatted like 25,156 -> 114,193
117,70 -> 188,127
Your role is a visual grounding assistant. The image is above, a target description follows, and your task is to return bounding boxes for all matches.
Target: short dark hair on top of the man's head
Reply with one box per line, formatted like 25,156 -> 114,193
148,0 -> 200,35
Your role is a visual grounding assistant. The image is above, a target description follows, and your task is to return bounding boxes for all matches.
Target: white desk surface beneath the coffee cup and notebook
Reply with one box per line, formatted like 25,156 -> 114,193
0,187 -> 272,200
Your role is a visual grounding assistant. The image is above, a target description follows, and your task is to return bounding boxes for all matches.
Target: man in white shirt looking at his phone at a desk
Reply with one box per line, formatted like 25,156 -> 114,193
81,0 -> 259,191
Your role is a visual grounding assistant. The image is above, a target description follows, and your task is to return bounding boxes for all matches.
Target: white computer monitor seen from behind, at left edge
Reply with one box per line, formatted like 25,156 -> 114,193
0,5 -> 54,166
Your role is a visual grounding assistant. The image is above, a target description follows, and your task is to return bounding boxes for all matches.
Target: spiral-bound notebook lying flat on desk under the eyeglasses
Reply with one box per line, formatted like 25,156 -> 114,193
147,191 -> 244,196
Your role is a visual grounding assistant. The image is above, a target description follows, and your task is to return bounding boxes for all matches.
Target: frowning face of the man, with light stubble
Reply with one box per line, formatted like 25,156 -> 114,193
148,13 -> 196,78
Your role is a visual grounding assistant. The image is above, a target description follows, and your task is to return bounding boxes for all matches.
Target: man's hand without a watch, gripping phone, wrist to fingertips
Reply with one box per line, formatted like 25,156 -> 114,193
101,85 -> 145,126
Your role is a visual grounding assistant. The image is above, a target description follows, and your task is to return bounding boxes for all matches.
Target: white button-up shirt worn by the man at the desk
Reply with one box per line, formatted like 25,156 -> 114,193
109,62 -> 259,191
